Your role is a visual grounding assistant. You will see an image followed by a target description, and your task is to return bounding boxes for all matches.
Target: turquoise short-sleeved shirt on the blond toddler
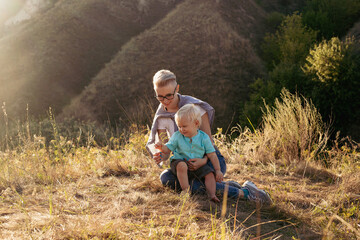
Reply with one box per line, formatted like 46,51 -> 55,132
166,130 -> 215,160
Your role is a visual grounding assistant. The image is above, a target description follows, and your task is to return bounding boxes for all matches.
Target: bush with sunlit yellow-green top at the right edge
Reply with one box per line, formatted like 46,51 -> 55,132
303,38 -> 360,137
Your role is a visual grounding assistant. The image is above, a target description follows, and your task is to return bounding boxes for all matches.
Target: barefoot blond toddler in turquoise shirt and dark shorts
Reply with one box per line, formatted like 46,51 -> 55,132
155,104 -> 223,202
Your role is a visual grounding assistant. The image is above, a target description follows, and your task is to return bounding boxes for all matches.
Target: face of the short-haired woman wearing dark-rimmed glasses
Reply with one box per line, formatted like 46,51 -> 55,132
154,82 -> 179,109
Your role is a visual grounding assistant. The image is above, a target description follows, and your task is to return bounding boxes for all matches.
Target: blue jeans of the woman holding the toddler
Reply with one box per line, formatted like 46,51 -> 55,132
160,148 -> 240,198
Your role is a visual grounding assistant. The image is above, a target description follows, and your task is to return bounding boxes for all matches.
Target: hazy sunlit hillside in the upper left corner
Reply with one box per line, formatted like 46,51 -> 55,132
0,0 -> 177,116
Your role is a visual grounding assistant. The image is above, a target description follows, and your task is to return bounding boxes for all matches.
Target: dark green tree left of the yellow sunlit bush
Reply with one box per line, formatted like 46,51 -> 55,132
240,13 -> 317,125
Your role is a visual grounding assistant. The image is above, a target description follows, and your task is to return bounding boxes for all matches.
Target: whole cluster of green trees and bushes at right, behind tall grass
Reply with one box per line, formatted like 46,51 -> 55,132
240,6 -> 360,141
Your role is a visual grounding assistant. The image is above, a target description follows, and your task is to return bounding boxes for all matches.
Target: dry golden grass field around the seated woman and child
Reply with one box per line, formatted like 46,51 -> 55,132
0,91 -> 360,239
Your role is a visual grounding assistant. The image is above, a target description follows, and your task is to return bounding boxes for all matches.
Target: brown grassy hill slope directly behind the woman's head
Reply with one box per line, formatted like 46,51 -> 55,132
64,0 -> 265,127
